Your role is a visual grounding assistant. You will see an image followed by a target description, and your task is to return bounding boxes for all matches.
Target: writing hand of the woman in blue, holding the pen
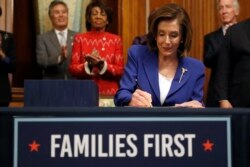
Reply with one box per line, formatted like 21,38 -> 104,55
128,89 -> 152,107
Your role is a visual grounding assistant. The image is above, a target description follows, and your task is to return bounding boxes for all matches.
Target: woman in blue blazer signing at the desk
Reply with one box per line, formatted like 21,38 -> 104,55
114,3 -> 205,108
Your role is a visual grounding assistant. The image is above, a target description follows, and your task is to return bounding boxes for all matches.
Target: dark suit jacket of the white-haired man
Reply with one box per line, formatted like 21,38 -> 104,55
203,28 -> 224,107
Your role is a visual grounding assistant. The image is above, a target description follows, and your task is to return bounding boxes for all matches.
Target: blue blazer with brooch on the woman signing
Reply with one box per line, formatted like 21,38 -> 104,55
114,45 -> 205,106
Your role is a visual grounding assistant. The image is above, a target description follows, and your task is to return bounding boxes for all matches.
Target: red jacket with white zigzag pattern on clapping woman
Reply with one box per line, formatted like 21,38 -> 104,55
69,31 -> 124,95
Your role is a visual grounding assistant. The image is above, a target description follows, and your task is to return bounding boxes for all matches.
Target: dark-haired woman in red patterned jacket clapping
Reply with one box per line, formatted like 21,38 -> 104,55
69,1 -> 124,98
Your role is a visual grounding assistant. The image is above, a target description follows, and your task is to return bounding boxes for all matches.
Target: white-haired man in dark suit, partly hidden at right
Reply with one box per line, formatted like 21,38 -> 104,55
203,0 -> 239,107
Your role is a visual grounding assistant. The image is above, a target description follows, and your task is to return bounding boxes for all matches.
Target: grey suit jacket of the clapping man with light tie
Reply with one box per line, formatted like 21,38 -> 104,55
36,30 -> 76,79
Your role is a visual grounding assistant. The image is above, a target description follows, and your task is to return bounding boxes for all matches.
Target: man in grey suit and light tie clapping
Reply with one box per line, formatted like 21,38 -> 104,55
36,0 -> 76,79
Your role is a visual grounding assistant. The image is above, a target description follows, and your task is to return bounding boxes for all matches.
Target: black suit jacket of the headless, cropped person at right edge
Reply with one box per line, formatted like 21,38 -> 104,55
216,19 -> 250,107
